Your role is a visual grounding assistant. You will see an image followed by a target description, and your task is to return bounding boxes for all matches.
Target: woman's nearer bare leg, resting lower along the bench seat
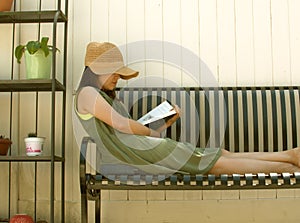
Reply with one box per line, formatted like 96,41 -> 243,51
209,156 -> 300,175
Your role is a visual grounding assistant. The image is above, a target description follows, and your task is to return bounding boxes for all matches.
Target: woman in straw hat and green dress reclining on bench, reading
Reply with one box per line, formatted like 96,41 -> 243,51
75,42 -> 300,175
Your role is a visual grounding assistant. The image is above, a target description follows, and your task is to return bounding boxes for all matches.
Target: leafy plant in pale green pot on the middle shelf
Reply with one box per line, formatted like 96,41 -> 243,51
15,37 -> 58,79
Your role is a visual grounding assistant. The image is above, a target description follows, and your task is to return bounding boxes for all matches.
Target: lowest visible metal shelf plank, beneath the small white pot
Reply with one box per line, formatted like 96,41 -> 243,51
0,156 -> 64,162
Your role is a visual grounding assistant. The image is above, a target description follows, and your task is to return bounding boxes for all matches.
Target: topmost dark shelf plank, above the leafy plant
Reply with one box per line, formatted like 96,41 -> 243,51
0,10 -> 68,23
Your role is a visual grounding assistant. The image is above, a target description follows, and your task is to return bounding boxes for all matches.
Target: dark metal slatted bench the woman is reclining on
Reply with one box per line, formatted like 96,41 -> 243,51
80,86 -> 300,222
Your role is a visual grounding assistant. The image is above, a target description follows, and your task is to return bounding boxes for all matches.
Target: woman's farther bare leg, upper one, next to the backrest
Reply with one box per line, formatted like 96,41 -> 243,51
222,148 -> 300,167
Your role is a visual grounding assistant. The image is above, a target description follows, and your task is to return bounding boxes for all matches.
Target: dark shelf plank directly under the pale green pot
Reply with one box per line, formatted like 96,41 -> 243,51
0,79 -> 66,92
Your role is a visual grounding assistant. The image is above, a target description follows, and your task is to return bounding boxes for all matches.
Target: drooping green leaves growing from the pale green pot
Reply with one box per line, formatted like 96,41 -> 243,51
15,37 -> 58,63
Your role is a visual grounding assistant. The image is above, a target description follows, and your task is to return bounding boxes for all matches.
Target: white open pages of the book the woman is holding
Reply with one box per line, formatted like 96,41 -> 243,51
137,101 -> 176,125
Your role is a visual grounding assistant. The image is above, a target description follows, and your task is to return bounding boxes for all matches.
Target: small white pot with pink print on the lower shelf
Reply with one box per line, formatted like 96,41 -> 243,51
24,133 -> 45,156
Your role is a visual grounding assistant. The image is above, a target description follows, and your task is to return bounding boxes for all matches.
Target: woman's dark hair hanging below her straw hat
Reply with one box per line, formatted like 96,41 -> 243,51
77,66 -> 116,99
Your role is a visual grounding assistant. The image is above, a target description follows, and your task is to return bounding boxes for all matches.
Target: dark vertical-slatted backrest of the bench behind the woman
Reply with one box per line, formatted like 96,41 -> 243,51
117,87 -> 300,152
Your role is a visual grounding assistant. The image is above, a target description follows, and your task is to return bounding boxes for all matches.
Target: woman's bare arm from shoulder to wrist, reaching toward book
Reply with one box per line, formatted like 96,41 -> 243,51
77,87 -> 160,137
